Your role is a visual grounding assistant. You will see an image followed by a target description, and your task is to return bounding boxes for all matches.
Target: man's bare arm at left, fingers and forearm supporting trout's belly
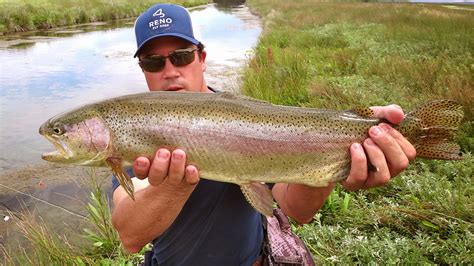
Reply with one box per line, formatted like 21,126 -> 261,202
112,149 -> 199,253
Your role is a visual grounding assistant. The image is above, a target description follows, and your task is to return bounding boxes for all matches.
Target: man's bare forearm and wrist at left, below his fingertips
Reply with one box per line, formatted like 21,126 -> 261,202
112,180 -> 194,253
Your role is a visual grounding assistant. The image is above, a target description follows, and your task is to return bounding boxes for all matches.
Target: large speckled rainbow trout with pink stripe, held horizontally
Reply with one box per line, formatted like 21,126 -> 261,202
39,92 -> 463,216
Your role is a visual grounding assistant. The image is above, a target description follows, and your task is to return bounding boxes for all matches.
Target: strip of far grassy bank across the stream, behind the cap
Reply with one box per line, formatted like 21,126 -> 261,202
0,0 -> 210,34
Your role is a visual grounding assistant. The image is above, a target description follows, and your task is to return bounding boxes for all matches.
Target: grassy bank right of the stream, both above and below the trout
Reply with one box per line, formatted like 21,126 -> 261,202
243,0 -> 474,264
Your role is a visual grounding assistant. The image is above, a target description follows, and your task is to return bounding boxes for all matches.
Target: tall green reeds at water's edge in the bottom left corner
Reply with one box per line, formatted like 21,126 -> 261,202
0,169 -> 149,265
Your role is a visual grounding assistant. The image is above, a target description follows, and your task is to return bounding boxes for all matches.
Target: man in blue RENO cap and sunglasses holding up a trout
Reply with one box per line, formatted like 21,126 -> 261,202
112,4 -> 415,265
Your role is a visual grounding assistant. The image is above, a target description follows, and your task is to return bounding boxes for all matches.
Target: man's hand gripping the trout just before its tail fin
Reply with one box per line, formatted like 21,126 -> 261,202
342,105 -> 416,191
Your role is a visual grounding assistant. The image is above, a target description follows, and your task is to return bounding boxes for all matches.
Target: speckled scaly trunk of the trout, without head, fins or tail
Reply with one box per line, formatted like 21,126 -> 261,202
100,94 -> 378,186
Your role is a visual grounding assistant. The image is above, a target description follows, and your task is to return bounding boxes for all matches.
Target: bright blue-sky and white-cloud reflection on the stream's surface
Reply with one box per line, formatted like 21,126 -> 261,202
0,5 -> 261,170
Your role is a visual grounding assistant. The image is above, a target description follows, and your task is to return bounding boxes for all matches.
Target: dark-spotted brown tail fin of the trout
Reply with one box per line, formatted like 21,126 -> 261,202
399,100 -> 464,160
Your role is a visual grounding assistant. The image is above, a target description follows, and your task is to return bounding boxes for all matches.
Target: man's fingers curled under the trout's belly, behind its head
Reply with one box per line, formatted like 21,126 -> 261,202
133,149 -> 199,186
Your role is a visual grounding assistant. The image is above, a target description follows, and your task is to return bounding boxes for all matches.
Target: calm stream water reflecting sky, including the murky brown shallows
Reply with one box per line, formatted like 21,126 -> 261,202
0,1 -> 261,249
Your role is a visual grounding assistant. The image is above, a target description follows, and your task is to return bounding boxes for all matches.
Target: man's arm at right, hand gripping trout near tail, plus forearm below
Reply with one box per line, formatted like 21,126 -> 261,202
272,105 -> 416,223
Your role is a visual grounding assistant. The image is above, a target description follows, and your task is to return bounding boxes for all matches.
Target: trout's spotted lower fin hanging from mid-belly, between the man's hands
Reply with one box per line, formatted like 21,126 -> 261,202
240,182 -> 273,217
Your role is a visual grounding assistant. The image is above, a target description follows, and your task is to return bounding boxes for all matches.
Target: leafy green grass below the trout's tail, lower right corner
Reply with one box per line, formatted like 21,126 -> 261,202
294,154 -> 474,265
